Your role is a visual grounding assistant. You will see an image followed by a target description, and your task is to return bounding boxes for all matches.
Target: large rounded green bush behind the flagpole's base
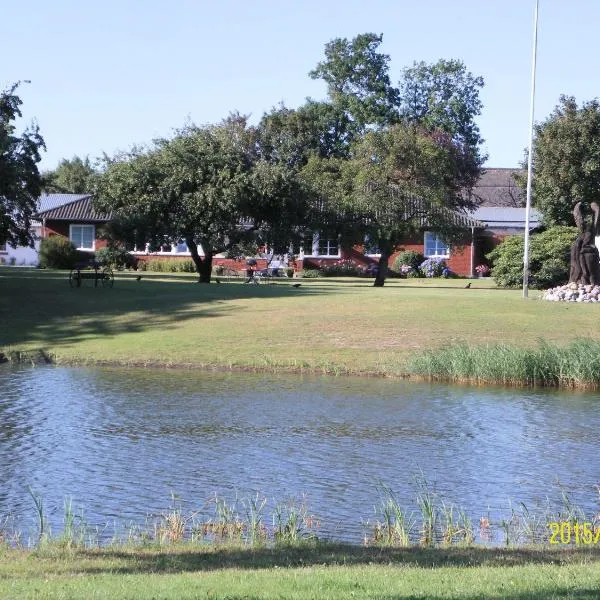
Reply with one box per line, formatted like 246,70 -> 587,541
487,226 -> 577,289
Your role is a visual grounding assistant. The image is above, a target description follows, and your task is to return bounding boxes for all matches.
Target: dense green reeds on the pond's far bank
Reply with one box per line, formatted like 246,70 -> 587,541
408,338 -> 600,389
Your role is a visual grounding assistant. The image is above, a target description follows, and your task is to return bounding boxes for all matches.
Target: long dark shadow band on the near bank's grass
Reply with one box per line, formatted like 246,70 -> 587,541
57,543 -> 600,573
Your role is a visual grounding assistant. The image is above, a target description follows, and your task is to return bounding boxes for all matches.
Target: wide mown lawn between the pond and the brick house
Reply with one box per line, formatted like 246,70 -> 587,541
0,268 -> 599,375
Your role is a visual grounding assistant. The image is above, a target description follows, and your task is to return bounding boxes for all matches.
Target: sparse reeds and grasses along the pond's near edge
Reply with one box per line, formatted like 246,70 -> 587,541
0,486 -> 600,549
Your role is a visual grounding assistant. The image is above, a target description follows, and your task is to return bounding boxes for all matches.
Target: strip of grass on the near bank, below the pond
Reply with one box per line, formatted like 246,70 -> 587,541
0,545 -> 600,600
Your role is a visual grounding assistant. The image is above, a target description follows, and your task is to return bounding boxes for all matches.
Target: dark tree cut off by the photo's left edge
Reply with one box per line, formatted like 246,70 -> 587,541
0,83 -> 45,246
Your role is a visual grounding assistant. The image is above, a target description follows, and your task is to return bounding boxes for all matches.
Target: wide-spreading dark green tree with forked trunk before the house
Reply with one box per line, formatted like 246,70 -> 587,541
96,115 -> 309,283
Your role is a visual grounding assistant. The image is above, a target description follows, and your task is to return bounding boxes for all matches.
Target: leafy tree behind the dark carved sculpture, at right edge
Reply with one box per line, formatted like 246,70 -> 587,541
523,96 -> 600,226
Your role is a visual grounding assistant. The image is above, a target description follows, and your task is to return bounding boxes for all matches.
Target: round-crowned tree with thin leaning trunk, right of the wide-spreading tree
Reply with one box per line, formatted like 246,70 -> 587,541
304,124 -> 473,286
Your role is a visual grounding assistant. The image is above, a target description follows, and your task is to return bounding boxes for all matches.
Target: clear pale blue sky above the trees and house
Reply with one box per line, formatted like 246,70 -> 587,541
0,0 -> 600,170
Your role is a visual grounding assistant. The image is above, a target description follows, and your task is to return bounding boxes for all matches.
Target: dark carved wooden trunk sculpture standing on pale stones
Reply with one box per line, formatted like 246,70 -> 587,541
569,202 -> 600,285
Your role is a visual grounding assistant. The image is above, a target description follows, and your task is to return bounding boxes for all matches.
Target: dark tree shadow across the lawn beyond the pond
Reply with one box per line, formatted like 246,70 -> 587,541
0,268 -> 326,349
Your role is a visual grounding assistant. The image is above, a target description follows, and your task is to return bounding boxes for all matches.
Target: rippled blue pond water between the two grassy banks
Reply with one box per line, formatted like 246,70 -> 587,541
0,367 -> 600,542
